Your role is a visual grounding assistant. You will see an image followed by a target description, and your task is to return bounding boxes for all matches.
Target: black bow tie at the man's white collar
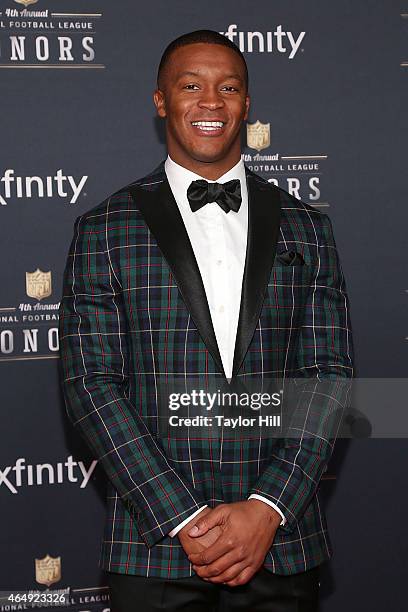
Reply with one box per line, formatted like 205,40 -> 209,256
187,179 -> 242,213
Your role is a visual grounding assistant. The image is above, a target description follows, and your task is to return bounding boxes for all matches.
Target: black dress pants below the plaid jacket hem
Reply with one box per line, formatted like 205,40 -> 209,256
107,566 -> 319,612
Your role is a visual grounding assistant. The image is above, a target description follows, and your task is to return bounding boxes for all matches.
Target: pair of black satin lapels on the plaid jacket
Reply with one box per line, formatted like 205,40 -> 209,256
129,163 -> 280,377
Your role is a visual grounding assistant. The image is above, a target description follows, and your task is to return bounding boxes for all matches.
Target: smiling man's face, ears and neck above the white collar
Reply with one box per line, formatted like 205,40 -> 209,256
154,43 -> 249,171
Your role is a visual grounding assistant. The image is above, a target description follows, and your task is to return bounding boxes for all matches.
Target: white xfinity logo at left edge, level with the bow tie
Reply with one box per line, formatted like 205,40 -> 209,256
0,168 -> 88,206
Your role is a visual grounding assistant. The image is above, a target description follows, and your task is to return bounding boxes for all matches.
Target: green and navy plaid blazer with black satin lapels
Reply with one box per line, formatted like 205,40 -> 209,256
59,162 -> 353,578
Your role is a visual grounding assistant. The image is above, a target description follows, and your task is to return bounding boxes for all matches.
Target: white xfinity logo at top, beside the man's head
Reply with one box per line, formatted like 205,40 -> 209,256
220,23 -> 306,59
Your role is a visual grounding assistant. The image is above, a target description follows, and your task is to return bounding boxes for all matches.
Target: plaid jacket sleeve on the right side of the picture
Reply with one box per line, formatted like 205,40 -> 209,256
249,214 -> 353,533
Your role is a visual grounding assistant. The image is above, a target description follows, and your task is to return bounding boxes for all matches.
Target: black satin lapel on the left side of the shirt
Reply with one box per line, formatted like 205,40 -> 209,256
129,177 -> 225,376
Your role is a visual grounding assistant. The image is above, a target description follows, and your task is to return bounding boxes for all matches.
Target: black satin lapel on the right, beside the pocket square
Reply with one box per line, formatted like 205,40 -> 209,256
232,168 -> 281,376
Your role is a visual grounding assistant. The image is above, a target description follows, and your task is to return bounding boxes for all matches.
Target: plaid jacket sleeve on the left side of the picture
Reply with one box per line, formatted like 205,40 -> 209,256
59,216 -> 205,547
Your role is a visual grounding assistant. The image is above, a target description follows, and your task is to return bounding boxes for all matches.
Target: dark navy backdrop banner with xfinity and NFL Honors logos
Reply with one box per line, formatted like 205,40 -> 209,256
0,0 -> 408,612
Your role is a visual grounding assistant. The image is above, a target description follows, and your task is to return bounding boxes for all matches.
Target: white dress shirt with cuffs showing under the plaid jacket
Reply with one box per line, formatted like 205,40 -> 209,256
164,155 -> 285,537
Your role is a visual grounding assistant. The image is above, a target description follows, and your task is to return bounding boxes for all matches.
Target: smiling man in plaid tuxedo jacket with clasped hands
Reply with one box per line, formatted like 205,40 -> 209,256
60,30 -> 352,612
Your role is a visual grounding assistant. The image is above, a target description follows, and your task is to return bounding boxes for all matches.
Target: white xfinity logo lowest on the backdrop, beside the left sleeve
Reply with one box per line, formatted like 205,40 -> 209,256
0,455 -> 98,494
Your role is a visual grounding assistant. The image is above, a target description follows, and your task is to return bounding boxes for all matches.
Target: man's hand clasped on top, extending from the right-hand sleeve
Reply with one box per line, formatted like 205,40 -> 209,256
186,499 -> 282,586
